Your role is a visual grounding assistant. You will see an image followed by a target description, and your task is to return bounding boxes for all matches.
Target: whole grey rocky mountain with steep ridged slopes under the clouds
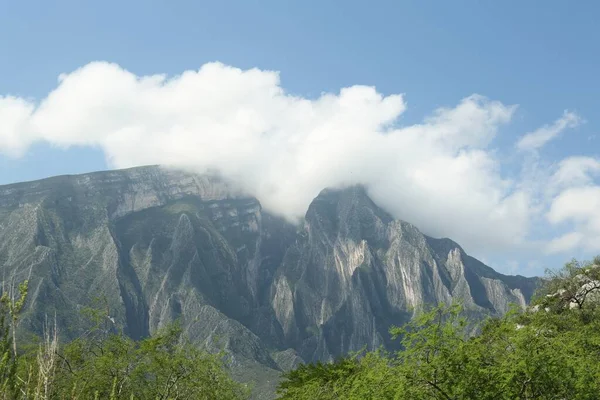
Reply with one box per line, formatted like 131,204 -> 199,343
0,166 -> 537,393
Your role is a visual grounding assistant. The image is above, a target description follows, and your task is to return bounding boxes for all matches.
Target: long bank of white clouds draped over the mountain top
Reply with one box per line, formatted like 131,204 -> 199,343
0,62 -> 600,258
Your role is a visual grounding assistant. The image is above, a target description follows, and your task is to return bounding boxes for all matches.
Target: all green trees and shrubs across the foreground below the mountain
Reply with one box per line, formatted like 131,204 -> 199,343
0,258 -> 600,400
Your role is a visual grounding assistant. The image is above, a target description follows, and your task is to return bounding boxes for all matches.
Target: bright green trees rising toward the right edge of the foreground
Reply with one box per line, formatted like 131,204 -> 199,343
278,259 -> 600,400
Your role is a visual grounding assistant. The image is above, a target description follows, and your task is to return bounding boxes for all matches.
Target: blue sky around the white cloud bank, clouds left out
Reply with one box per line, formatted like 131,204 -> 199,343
0,0 -> 600,275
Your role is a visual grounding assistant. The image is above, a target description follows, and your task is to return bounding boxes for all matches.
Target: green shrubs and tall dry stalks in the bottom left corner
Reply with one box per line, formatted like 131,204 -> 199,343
0,282 -> 248,400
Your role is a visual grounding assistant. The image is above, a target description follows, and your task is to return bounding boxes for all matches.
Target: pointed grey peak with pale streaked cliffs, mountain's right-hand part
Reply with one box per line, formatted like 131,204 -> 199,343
271,187 -> 535,361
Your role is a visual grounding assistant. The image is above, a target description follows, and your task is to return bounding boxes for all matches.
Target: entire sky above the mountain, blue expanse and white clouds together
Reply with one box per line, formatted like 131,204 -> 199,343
0,0 -> 600,275
